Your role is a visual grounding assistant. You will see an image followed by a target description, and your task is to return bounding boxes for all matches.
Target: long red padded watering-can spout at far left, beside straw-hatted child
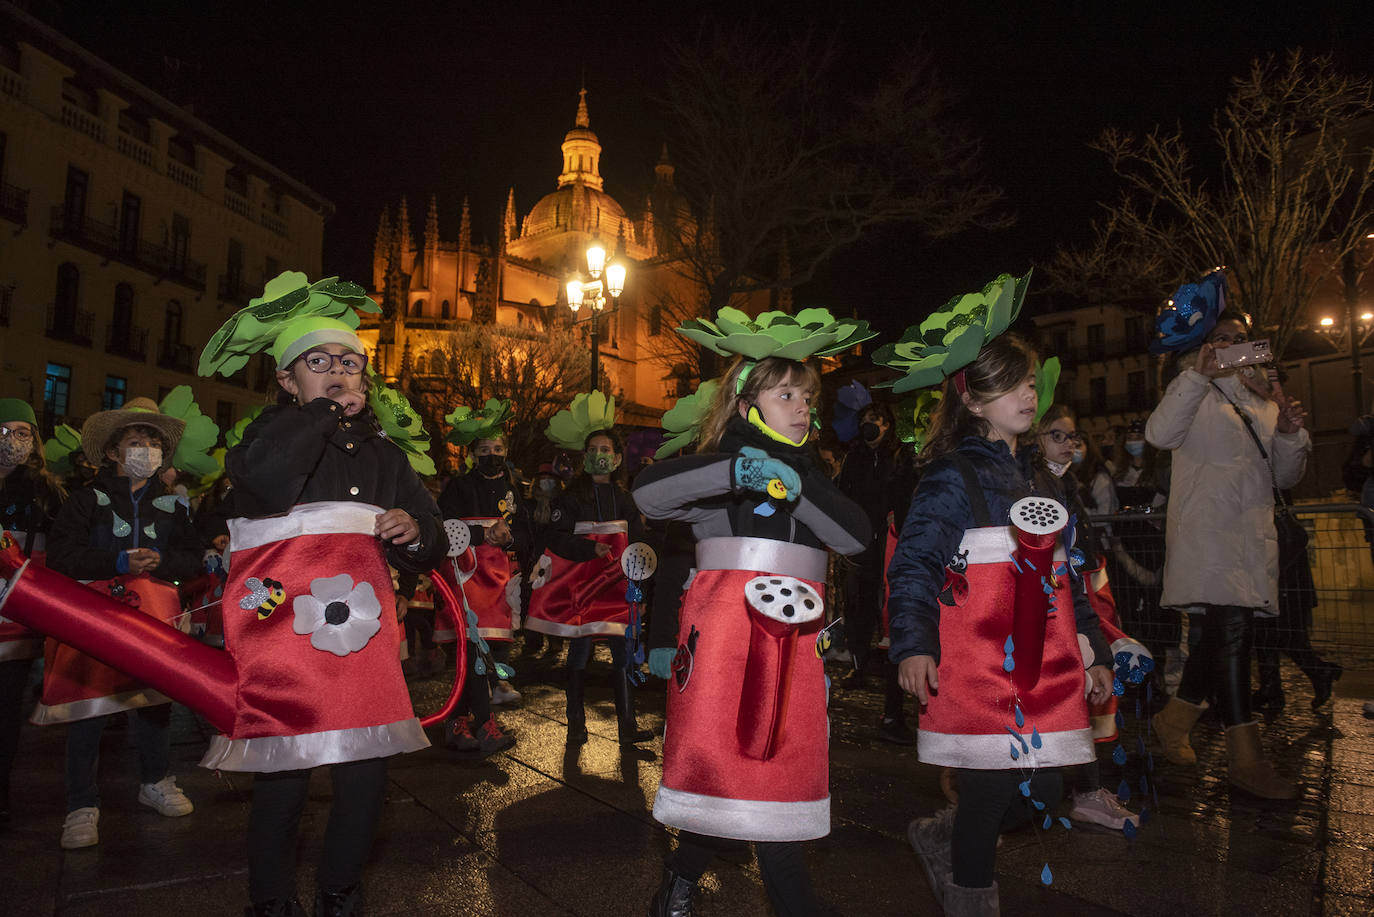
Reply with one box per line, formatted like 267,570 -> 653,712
0,564 -> 238,734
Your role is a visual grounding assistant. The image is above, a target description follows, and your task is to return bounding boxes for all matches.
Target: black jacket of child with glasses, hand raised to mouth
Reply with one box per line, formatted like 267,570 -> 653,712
224,397 -> 448,573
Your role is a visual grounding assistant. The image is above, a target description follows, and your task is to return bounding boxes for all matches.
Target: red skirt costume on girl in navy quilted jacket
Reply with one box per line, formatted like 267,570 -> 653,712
916,525 -> 1094,770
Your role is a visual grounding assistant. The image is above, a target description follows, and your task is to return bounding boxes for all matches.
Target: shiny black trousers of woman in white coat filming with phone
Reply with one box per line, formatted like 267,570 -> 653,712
1179,605 -> 1254,726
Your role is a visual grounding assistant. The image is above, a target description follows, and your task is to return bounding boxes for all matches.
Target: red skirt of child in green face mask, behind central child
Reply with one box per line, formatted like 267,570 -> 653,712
525,520 -> 629,637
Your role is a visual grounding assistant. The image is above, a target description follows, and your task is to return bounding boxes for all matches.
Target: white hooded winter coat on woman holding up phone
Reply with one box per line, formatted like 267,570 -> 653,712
1145,370 -> 1312,616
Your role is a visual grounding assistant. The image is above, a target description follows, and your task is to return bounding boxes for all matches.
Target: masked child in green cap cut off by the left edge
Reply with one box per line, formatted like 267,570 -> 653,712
0,399 -> 66,828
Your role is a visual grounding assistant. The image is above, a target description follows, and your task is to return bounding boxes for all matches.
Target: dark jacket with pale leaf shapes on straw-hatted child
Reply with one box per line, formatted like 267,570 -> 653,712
48,466 -> 203,583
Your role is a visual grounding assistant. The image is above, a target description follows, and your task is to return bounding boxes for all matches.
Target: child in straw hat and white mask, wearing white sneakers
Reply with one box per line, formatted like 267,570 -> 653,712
43,397 -> 202,850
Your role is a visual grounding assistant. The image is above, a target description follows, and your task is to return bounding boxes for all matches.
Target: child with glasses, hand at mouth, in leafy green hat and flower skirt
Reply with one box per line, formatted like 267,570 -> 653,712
201,272 -> 448,917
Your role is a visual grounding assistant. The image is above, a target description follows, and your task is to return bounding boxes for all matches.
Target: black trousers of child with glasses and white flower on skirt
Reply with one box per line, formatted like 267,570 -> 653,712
249,758 -> 386,903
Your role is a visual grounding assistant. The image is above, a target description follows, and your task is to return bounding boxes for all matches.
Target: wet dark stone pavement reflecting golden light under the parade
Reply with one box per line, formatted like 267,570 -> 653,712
0,646 -> 1374,917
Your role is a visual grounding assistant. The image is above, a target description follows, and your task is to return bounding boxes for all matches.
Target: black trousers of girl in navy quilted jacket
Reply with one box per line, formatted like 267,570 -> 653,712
951,767 -> 1063,888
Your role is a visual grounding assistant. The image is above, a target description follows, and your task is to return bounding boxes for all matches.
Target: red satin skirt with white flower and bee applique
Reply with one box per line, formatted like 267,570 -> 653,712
201,502 -> 429,771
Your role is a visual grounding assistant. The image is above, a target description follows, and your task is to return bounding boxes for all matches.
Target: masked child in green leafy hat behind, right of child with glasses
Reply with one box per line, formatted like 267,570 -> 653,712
438,399 -> 530,758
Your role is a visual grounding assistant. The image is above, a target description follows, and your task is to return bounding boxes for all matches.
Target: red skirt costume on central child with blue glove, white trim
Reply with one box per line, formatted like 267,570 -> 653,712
654,538 -> 830,841
